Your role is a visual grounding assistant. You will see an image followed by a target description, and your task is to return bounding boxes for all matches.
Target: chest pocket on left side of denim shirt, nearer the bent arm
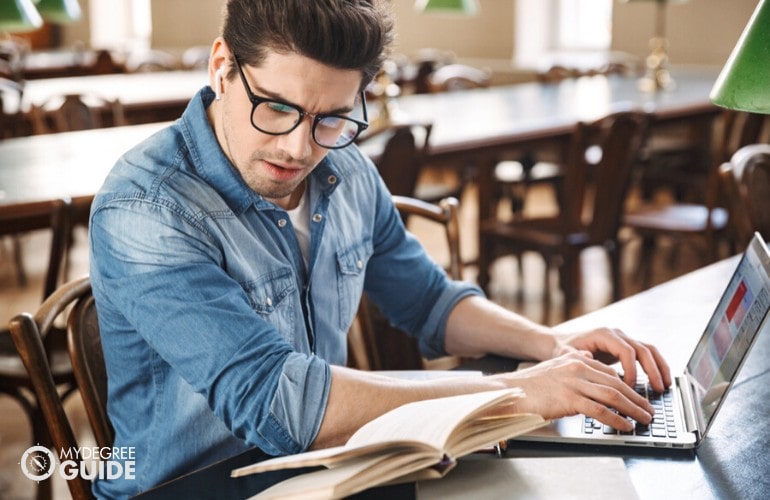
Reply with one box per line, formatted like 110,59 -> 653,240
243,268 -> 304,350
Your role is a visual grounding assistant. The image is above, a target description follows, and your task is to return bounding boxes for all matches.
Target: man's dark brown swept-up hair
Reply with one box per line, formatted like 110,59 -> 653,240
222,0 -> 393,89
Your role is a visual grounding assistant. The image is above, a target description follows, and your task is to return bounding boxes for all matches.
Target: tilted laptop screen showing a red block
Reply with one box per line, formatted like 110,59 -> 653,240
687,234 -> 770,427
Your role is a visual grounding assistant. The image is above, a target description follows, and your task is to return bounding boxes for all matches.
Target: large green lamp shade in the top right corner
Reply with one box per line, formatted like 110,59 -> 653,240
711,0 -> 770,113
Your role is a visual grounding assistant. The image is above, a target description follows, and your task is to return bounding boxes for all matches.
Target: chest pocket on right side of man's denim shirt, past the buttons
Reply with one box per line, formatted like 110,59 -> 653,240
337,240 -> 373,329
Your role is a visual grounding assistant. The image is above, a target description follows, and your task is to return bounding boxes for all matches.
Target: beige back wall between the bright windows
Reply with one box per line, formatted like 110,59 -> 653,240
64,0 -> 757,72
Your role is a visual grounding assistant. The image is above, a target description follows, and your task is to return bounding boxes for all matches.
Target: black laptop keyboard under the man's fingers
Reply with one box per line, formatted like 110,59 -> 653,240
583,384 -> 677,439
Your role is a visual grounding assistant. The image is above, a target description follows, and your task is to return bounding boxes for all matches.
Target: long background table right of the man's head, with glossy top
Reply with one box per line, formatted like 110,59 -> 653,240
368,68 -> 721,228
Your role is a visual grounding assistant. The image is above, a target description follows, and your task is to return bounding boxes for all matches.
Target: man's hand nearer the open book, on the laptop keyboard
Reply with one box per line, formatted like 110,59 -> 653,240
492,351 -> 654,431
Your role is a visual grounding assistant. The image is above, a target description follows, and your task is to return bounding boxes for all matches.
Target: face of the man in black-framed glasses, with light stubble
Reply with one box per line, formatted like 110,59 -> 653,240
208,43 -> 361,208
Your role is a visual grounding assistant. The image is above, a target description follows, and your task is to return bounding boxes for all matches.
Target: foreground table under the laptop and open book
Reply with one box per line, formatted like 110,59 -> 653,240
135,257 -> 770,500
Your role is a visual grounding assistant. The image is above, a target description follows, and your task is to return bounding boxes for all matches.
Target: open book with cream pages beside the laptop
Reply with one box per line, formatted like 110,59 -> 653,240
231,389 -> 547,499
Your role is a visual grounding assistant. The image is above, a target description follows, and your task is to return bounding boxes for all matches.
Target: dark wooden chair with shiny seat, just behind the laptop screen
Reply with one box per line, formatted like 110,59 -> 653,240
623,110 -> 765,288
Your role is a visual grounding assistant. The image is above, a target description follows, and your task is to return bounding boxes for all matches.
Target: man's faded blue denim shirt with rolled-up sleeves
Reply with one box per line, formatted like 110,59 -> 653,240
90,87 -> 480,497
